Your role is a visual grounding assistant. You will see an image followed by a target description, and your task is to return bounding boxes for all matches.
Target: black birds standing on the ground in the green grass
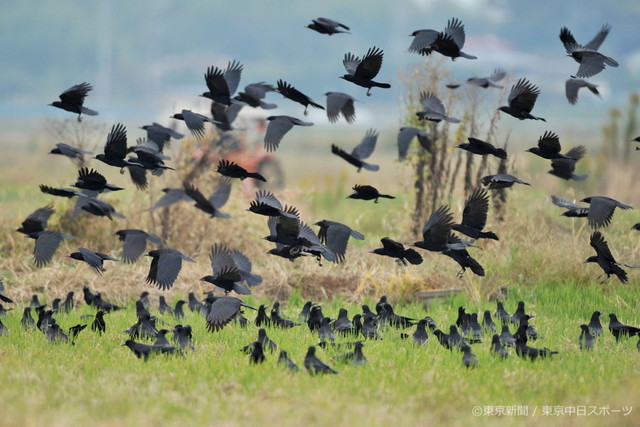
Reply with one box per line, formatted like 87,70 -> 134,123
0,280 -> 640,374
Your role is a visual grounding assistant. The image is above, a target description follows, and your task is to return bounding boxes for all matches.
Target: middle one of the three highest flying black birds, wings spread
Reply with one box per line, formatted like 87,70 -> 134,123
409,18 -> 478,59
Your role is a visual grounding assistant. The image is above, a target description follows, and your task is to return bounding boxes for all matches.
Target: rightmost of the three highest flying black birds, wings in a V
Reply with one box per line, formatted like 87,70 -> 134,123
560,24 -> 619,77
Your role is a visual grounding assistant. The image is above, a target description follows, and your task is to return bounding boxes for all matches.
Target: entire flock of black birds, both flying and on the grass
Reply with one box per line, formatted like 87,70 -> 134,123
0,18 -> 640,373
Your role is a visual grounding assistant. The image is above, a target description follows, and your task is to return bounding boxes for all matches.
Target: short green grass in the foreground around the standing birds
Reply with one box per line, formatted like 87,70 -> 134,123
0,282 -> 640,425
